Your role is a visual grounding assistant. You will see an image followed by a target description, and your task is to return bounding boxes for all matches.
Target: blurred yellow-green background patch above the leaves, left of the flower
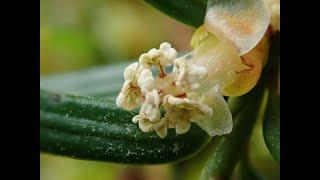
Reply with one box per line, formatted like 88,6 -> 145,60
40,0 -> 193,74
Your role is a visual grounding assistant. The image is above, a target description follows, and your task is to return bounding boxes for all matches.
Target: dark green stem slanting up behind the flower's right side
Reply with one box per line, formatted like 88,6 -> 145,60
201,34 -> 280,180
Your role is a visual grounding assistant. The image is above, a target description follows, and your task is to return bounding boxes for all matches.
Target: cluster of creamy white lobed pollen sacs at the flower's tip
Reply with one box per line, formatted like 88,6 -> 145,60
116,42 -> 219,138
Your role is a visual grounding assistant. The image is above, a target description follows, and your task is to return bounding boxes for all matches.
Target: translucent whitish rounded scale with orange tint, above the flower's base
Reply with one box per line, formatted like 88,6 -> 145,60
204,0 -> 270,56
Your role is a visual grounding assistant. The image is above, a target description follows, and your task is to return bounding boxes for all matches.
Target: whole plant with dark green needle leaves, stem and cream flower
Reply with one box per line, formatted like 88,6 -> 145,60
40,0 -> 280,179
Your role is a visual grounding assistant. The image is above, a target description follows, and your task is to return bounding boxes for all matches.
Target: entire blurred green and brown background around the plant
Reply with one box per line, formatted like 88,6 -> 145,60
40,0 -> 279,180
